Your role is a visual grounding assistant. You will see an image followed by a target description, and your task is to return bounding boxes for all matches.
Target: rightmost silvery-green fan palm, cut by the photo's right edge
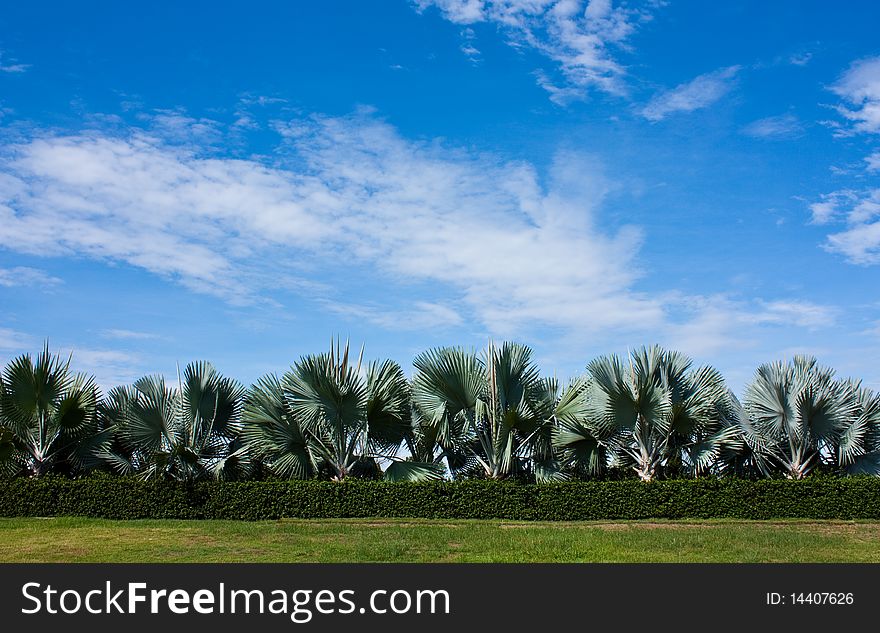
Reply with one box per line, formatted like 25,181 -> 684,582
744,356 -> 880,479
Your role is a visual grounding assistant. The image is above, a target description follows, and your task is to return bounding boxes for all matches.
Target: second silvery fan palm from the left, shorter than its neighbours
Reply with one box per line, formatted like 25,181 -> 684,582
101,362 -> 249,481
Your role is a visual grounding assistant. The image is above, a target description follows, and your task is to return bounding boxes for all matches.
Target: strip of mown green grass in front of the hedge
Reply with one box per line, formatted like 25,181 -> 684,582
0,518 -> 880,562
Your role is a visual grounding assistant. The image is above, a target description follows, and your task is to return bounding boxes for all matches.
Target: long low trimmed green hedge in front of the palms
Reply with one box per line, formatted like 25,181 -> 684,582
0,477 -> 880,521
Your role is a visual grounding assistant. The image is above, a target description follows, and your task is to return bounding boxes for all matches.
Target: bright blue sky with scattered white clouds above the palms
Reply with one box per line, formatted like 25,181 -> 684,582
0,0 -> 880,389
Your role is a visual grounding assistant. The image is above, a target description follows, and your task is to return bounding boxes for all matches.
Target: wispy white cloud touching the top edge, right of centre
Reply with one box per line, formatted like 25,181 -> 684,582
414,0 -> 662,103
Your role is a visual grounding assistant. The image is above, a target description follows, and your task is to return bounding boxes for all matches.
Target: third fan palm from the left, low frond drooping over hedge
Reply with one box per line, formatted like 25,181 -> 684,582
242,342 -> 442,481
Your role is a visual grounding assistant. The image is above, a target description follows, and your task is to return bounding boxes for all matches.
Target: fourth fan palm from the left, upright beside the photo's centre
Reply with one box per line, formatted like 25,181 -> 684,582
413,342 -> 558,480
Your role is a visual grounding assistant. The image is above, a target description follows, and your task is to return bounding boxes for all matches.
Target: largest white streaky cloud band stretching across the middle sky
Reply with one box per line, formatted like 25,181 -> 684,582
0,111 -> 840,358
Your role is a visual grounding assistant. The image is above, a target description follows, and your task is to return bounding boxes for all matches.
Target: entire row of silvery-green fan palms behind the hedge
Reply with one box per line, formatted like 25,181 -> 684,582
0,342 -> 880,482
